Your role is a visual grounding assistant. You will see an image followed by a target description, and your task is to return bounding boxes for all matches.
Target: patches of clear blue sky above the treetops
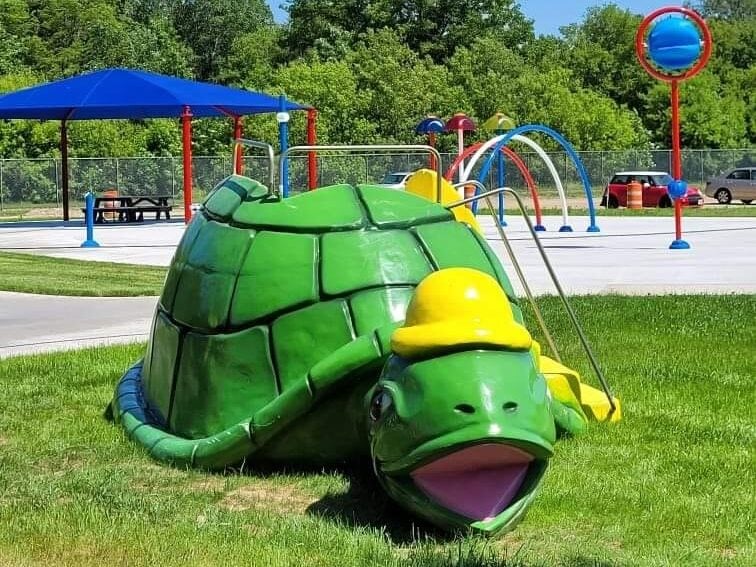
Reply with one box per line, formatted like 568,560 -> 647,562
267,0 -> 682,35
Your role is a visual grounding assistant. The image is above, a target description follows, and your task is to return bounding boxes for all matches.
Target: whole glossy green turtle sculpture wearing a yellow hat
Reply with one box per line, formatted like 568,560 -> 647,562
110,176 -> 604,533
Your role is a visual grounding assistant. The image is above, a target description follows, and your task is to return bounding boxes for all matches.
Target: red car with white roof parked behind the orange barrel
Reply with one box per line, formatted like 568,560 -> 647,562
601,171 -> 704,209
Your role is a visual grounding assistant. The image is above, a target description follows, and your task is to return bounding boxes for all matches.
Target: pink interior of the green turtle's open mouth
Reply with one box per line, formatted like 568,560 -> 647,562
411,443 -> 533,520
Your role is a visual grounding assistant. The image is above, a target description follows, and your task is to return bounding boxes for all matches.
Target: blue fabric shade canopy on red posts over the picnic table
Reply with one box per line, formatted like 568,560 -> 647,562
0,69 -> 310,120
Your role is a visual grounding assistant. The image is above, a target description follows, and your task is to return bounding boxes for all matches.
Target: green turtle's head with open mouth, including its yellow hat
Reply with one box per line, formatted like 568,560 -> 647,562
366,268 -> 556,533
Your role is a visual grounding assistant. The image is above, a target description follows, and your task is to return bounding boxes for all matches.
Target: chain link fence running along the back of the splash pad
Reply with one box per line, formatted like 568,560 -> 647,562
0,148 -> 756,218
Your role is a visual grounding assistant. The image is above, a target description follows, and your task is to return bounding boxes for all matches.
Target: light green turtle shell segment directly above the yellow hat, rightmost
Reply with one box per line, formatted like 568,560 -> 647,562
413,221 -> 516,299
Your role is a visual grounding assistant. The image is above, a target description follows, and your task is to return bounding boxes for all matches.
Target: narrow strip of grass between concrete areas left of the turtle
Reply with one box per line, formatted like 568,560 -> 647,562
0,252 -> 166,297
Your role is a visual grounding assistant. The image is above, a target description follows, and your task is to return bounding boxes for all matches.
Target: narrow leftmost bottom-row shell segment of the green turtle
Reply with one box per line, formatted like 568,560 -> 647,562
142,312 -> 180,421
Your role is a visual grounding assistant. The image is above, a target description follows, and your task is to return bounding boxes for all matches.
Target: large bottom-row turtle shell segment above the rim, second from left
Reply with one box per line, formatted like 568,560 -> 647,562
170,327 -> 279,439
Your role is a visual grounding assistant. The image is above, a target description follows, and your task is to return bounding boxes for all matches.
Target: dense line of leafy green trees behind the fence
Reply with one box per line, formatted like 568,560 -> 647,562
0,0 -> 756,157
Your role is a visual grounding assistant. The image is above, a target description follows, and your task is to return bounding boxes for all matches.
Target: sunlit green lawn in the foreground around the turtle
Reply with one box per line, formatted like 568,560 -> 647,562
0,295 -> 756,567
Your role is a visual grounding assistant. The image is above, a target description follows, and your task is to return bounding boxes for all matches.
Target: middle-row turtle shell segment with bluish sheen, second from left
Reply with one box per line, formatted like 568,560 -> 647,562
172,221 -> 254,330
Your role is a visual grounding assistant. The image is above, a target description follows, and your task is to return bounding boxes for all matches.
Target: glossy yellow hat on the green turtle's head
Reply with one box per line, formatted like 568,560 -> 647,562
391,268 -> 533,358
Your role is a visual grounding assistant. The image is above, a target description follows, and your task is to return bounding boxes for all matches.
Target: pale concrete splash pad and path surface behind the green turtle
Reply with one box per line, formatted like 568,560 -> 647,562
0,216 -> 756,357
